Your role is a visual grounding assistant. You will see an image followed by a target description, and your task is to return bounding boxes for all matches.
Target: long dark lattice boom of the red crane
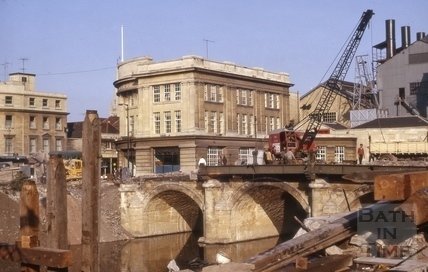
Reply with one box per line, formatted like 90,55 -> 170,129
297,9 -> 374,150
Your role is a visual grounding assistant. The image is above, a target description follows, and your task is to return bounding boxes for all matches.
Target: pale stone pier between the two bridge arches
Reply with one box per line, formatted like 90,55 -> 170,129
200,179 -> 232,244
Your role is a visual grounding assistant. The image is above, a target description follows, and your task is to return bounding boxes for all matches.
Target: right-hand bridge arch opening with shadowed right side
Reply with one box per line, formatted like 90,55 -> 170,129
230,180 -> 310,241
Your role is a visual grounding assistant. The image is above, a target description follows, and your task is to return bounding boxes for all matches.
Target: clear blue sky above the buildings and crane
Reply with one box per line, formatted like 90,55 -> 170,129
0,0 -> 428,122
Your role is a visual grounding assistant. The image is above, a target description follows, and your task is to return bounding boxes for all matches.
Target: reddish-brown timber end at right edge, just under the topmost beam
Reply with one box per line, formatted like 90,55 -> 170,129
399,187 -> 428,225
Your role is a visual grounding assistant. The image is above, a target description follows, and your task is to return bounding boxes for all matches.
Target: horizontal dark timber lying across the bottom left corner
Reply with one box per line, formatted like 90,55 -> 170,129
0,244 -> 73,268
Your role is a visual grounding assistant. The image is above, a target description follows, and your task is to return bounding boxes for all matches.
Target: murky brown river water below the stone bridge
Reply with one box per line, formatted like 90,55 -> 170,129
70,233 -> 284,272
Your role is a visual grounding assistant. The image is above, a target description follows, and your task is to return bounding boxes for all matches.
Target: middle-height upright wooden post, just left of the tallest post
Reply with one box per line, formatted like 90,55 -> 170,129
46,156 -> 68,249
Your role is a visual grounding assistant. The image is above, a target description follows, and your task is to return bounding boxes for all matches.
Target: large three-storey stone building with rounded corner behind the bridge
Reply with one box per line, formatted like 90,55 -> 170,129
114,56 -> 293,175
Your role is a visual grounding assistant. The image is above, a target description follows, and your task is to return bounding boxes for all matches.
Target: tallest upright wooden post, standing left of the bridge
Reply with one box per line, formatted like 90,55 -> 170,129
81,110 -> 101,272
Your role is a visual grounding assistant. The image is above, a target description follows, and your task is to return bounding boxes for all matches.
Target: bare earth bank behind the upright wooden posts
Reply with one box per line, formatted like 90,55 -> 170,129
0,171 -> 130,246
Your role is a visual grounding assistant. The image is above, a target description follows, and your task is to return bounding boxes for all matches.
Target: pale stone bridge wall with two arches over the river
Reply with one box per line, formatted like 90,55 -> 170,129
120,177 -> 372,244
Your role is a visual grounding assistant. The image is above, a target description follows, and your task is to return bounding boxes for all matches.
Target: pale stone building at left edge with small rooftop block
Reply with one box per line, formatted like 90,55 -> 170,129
0,73 -> 68,157
